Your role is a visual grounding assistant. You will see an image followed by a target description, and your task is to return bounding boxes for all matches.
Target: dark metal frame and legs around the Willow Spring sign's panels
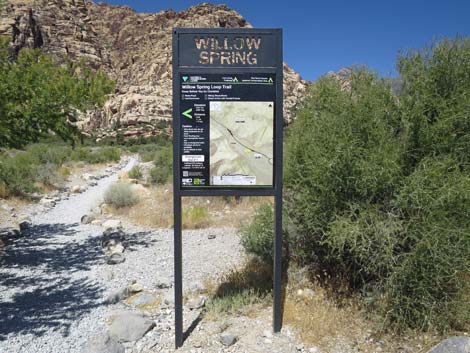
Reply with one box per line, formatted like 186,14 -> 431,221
172,28 -> 284,348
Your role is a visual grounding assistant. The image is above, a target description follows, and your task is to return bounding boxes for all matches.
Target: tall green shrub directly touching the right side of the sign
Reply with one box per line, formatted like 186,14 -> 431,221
285,70 -> 402,266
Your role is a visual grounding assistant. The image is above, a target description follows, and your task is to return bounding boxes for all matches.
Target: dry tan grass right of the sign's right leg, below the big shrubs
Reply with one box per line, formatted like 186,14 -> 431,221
284,282 -> 443,353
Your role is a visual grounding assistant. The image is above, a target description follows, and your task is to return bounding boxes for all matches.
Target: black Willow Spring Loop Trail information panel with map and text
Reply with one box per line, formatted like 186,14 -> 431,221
180,73 -> 276,187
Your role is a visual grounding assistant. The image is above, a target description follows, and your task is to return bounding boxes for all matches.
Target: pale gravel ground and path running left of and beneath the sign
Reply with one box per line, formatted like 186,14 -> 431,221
0,157 -> 317,353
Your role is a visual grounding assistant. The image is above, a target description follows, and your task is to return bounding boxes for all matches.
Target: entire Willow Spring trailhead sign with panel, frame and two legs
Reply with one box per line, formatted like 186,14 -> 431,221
173,28 -> 283,348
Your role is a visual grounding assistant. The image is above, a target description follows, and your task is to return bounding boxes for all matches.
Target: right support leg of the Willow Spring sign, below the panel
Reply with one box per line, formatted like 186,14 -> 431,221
273,191 -> 282,332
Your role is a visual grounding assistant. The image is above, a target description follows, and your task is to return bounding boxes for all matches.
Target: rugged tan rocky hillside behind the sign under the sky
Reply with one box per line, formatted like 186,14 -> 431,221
0,0 -> 306,137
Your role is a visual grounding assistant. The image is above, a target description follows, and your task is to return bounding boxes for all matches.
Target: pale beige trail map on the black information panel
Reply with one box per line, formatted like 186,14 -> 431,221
209,101 -> 274,185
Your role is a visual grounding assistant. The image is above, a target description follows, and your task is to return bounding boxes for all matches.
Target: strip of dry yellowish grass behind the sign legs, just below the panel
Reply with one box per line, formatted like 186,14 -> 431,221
107,183 -> 272,229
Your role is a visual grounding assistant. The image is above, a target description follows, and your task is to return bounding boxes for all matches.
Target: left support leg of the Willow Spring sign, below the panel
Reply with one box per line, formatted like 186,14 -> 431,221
173,195 -> 183,349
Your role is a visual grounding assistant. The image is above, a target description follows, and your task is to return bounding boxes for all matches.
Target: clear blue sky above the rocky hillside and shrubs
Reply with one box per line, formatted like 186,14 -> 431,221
102,0 -> 470,80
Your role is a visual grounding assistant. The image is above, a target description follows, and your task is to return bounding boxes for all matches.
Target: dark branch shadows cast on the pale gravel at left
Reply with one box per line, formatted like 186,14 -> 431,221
0,223 -> 157,340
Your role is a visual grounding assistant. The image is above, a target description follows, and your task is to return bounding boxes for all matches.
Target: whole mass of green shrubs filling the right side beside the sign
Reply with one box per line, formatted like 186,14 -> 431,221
243,38 -> 470,330
